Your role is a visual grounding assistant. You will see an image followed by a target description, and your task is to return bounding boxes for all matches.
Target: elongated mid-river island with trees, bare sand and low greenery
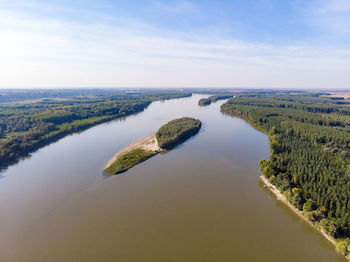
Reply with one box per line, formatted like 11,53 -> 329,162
105,117 -> 202,175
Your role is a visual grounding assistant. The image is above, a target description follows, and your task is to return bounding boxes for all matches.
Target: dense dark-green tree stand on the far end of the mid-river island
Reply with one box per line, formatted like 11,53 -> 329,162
156,117 -> 202,150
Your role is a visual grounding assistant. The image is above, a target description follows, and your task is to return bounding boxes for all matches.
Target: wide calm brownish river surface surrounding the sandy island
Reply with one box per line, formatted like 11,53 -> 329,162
0,95 -> 345,262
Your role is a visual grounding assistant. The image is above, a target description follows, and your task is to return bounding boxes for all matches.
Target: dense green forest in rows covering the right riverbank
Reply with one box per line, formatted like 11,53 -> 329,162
221,94 -> 350,254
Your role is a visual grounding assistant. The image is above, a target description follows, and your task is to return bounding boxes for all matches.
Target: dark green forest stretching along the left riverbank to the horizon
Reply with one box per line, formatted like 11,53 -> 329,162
0,90 -> 191,168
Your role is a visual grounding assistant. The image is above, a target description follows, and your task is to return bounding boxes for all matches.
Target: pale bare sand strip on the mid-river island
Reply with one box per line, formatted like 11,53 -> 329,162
105,133 -> 162,170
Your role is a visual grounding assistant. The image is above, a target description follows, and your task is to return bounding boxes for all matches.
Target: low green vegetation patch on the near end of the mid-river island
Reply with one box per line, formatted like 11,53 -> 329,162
106,148 -> 157,175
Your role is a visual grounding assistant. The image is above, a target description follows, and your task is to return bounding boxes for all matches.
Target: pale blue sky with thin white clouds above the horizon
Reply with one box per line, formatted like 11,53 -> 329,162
0,0 -> 350,89
